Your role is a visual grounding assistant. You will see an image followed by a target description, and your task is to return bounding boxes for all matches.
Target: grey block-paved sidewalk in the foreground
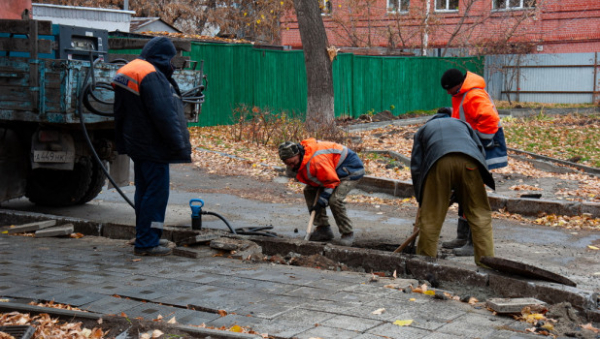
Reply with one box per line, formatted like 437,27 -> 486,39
0,235 -> 538,339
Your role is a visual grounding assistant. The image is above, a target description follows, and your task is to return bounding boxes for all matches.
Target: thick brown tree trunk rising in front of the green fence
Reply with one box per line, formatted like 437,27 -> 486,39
294,0 -> 335,132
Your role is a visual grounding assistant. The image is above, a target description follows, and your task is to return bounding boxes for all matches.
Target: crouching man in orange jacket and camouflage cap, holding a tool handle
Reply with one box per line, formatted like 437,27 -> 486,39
279,138 -> 365,246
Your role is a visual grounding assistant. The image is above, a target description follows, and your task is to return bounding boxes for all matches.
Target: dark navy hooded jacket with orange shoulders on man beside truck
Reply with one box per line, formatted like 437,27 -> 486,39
112,37 -> 191,163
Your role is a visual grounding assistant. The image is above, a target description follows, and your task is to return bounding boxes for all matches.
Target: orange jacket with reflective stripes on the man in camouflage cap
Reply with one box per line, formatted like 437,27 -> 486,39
296,138 -> 365,206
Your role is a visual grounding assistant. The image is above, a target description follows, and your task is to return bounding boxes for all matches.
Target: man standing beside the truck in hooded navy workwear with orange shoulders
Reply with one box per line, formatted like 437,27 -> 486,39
112,37 -> 192,256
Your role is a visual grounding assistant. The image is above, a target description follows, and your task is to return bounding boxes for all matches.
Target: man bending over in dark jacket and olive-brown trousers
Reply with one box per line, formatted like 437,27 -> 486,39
410,113 -> 495,266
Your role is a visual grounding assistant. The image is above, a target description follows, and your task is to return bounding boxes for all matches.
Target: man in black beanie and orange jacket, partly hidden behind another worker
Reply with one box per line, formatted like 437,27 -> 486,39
438,68 -> 508,256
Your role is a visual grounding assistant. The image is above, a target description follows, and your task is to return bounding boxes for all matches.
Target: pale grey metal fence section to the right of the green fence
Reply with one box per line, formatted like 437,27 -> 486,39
485,53 -> 600,104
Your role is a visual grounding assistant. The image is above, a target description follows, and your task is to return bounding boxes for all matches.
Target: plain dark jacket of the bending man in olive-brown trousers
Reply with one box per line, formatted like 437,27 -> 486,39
410,113 -> 496,204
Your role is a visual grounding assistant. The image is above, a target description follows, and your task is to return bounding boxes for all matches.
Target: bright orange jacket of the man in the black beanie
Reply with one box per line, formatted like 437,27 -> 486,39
452,72 -> 500,146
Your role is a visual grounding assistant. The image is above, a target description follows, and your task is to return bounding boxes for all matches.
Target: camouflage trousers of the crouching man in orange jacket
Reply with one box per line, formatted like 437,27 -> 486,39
304,179 -> 360,234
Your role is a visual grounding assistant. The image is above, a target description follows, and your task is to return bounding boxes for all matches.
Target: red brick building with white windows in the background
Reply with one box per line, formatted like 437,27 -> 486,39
281,0 -> 600,56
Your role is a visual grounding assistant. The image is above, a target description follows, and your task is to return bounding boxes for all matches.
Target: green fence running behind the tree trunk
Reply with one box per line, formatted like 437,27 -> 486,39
109,42 -> 484,126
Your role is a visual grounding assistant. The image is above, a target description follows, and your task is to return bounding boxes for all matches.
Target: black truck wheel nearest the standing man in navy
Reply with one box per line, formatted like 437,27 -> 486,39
26,157 -> 92,207
